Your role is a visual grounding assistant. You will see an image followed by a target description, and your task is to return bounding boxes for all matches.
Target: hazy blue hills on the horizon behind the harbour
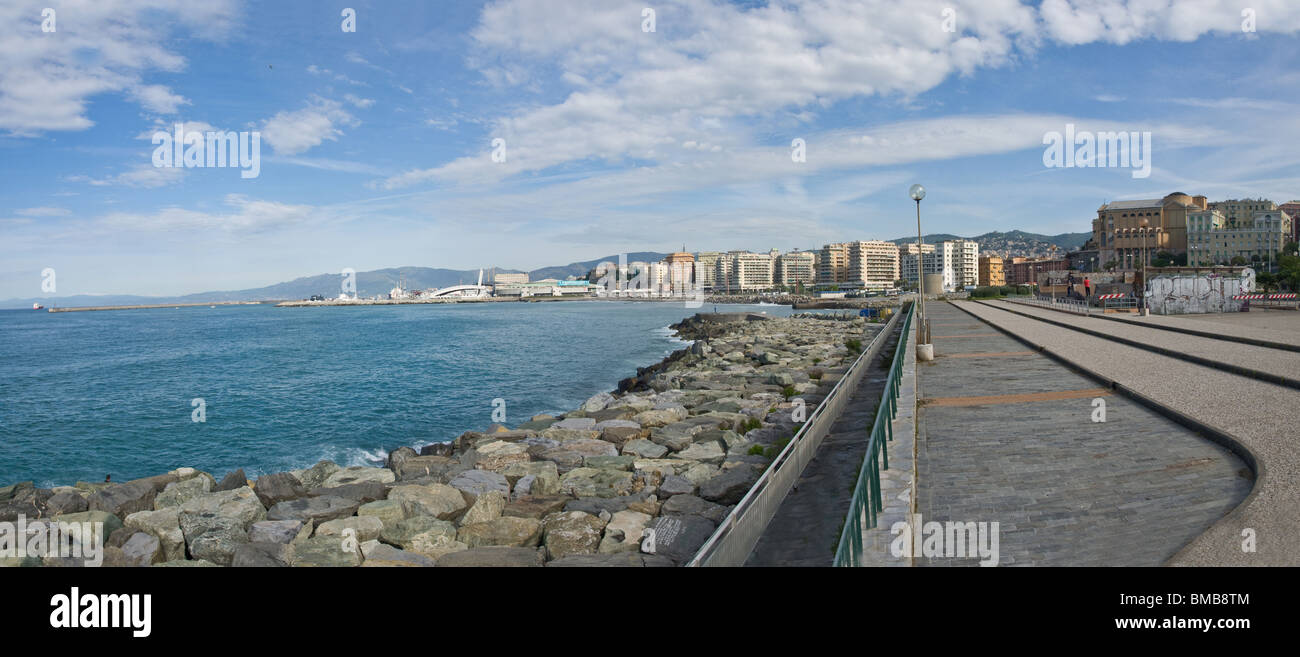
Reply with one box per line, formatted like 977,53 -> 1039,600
0,251 -> 666,308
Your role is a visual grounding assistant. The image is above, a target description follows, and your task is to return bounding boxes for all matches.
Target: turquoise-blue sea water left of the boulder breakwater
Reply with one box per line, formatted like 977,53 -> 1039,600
0,302 -> 790,487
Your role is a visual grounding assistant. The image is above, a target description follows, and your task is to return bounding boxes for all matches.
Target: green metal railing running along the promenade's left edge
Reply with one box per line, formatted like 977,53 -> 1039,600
835,303 -> 917,566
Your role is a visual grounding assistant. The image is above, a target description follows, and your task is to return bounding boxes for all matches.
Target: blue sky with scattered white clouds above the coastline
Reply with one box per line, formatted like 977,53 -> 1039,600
0,0 -> 1300,299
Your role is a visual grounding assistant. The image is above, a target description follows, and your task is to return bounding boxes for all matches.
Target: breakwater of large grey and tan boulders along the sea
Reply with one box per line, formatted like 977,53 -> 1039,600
0,315 -> 880,567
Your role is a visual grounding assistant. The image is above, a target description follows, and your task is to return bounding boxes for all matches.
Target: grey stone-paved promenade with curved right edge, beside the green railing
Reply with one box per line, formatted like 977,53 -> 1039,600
917,303 -> 1252,566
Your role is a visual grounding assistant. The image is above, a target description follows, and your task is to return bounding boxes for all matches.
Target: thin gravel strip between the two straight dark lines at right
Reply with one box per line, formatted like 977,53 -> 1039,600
1002,302 -> 1300,379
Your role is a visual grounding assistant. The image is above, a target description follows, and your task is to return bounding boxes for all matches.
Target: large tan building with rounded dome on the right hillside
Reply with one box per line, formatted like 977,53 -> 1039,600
1092,191 -> 1209,269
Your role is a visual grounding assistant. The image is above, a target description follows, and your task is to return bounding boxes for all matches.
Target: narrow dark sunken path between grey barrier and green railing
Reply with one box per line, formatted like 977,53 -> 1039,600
745,321 -> 910,566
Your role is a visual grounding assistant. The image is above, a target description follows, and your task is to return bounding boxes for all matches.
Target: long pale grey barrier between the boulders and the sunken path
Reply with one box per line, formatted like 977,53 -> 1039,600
686,303 -> 915,567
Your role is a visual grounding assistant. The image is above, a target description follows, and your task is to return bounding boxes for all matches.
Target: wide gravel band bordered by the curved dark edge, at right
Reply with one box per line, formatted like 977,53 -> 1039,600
967,302 -> 1300,566
